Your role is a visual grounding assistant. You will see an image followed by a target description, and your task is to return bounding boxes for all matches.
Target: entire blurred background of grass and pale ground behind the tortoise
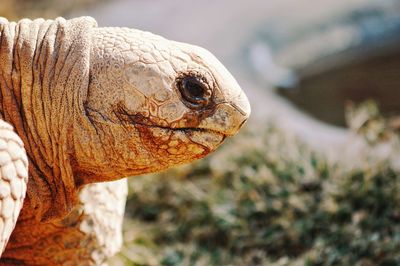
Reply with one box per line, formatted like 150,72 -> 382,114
0,0 -> 400,266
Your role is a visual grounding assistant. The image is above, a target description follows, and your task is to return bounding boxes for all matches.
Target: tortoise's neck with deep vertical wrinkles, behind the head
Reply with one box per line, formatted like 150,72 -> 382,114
0,18 -> 94,221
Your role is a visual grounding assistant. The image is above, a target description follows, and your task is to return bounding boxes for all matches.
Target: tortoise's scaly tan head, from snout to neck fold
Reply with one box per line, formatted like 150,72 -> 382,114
74,28 -> 250,183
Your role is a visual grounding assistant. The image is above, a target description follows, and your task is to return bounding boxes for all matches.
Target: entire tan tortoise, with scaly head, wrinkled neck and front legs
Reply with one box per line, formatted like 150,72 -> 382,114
0,18 -> 250,265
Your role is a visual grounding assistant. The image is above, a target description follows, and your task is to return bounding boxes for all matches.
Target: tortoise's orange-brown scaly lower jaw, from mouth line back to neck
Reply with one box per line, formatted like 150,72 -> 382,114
74,108 -> 230,185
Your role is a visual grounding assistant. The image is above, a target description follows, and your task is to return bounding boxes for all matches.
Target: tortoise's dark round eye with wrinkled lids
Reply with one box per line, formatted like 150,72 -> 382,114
178,76 -> 212,109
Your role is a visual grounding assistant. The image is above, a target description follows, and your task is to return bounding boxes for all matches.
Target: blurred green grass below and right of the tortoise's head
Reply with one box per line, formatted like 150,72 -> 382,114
112,106 -> 400,266
